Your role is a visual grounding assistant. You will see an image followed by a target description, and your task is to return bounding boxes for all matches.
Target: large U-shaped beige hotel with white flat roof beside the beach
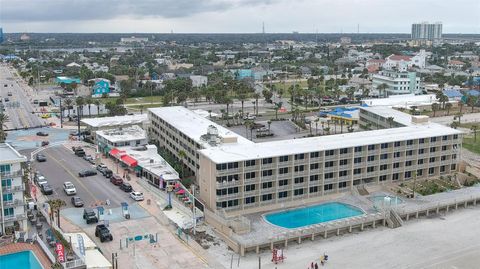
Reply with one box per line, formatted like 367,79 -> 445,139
149,107 -> 461,216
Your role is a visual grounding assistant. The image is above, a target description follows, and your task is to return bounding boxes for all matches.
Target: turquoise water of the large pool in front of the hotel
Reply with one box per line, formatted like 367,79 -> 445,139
265,203 -> 363,229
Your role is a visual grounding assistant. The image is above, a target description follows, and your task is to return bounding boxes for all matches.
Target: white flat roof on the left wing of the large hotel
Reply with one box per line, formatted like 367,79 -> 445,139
148,106 -> 255,148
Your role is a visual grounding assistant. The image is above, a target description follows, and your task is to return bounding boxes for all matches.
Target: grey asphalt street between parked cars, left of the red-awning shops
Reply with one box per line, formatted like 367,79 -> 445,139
33,146 -> 133,208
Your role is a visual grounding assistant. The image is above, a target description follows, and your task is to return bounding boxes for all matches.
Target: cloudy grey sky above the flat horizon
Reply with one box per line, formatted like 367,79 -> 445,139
0,0 -> 480,33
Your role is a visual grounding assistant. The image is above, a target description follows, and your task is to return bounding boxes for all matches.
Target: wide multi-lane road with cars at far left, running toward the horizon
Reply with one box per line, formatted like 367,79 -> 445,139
0,64 -> 45,129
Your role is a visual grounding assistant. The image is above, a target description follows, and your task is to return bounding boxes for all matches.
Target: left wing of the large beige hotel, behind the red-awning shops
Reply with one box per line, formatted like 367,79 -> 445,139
148,106 -> 254,175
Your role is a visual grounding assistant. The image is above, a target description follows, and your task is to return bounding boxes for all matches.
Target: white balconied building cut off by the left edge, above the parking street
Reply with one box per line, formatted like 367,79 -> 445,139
0,143 -> 27,234
